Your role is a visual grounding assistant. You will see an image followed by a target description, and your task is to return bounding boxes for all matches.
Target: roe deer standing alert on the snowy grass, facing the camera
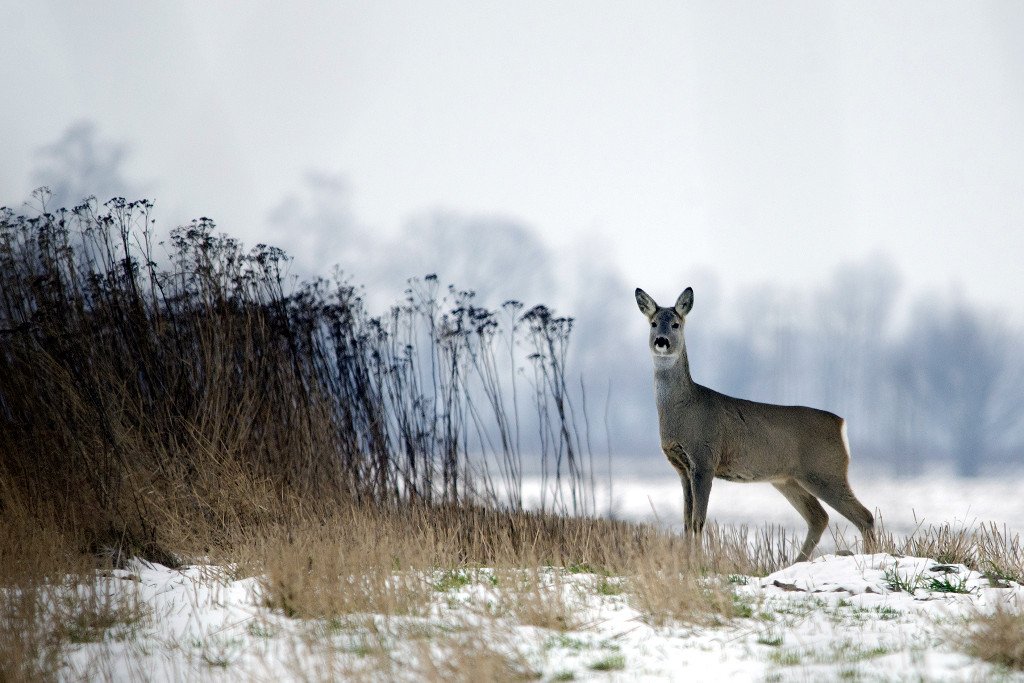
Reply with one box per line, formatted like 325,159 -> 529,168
636,287 -> 874,562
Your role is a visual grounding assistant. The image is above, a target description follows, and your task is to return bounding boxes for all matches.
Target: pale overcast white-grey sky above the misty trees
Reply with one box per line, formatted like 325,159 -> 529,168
0,0 -> 1024,313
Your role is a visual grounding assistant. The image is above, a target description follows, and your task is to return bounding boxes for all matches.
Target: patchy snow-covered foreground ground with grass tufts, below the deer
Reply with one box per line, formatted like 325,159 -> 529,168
62,554 -> 1024,682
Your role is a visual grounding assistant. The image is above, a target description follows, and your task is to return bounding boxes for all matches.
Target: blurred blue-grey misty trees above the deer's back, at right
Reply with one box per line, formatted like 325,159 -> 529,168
675,260 -> 1024,476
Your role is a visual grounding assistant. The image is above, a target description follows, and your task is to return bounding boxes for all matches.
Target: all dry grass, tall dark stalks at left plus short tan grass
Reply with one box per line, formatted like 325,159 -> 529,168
0,196 -> 1024,681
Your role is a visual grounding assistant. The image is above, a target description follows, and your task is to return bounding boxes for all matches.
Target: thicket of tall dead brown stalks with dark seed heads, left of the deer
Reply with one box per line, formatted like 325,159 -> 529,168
0,193 -> 588,562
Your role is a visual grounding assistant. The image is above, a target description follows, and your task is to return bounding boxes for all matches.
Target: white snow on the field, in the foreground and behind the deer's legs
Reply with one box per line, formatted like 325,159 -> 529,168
19,473 -> 1024,682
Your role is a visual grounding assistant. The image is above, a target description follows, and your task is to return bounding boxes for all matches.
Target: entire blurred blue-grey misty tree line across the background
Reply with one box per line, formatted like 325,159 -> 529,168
16,123 -> 1024,476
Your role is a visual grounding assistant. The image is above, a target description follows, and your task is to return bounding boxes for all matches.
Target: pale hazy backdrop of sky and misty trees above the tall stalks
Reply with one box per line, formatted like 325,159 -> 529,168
6,1 -> 1024,479
